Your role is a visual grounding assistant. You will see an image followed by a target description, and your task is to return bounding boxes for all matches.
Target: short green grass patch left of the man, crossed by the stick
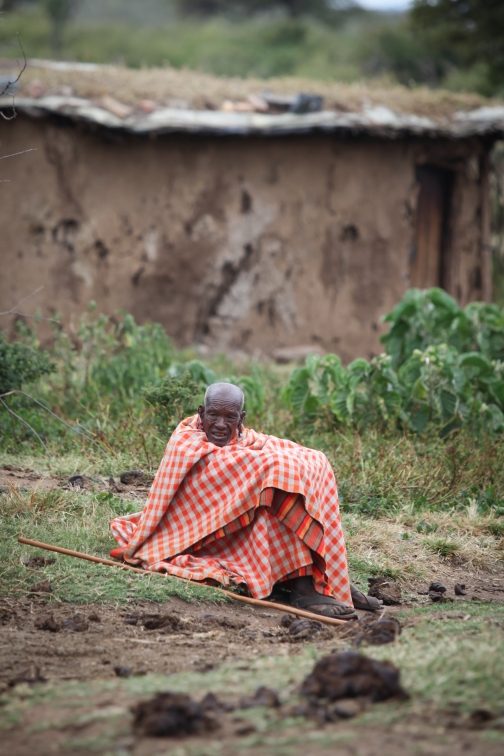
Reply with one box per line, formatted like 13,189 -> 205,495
0,490 -> 227,604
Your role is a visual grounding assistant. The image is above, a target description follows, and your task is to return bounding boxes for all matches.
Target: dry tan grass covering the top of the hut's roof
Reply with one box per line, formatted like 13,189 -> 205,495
0,61 -> 494,120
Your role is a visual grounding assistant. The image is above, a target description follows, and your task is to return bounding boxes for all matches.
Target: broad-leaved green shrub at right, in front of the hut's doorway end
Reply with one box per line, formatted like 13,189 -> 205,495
284,289 -> 504,436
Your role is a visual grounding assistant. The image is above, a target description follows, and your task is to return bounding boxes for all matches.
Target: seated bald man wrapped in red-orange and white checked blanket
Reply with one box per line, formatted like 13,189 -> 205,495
111,383 -> 378,619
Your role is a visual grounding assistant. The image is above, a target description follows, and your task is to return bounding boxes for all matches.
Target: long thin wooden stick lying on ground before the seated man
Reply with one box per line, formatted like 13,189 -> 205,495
18,536 -> 348,625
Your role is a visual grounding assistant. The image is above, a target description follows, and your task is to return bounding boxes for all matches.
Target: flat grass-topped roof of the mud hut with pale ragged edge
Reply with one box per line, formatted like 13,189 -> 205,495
0,61 -> 504,138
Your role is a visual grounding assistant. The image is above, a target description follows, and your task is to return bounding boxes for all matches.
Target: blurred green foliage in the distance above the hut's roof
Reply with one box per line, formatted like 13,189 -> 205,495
0,0 -> 504,95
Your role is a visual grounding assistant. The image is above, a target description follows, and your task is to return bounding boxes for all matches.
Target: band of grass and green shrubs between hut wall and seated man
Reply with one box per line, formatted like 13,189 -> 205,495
0,289 -> 504,524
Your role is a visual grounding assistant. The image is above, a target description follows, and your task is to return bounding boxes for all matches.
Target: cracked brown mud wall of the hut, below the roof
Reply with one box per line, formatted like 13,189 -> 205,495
0,116 -> 488,361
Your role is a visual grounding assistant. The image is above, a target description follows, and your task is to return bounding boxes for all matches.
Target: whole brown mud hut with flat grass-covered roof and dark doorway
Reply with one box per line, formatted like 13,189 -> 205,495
0,62 -> 504,360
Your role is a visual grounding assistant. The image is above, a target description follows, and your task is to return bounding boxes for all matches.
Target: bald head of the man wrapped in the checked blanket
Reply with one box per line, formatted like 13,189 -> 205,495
198,383 -> 245,448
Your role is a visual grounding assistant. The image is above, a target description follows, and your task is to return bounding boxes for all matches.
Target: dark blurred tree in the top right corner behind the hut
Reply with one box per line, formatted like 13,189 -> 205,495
410,0 -> 504,91
